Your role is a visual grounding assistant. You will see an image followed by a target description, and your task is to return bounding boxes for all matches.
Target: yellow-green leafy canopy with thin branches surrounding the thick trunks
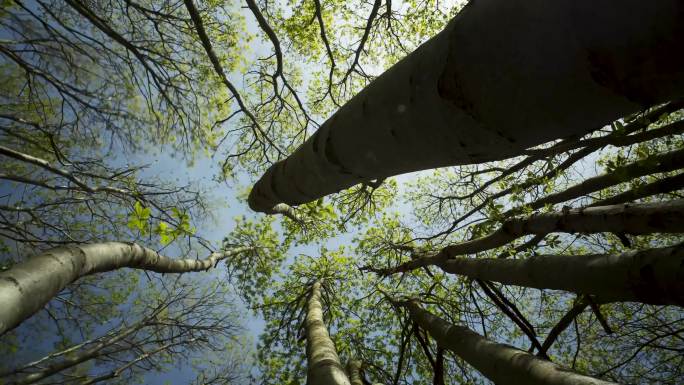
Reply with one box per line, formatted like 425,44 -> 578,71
0,0 -> 684,384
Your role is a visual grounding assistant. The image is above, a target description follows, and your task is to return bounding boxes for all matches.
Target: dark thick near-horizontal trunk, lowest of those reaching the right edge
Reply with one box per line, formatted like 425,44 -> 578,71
438,245 -> 684,306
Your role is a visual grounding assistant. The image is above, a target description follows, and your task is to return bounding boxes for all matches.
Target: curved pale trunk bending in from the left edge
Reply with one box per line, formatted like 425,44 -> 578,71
0,242 -> 251,335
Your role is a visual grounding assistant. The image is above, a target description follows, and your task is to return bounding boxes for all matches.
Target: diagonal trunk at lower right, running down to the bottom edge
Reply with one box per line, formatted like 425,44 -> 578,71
399,301 -> 613,385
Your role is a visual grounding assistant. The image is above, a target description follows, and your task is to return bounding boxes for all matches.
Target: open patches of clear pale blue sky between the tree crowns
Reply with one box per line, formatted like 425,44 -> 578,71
0,1 -> 460,384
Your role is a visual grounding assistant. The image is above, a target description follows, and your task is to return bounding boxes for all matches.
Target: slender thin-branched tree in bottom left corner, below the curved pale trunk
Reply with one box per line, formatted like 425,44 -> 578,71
0,280 -> 244,384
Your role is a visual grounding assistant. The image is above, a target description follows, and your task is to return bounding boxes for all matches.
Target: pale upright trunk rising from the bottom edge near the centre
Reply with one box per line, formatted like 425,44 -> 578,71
304,281 -> 350,385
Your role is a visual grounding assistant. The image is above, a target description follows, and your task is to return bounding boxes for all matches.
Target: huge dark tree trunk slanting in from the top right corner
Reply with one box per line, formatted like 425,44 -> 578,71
249,0 -> 684,212
